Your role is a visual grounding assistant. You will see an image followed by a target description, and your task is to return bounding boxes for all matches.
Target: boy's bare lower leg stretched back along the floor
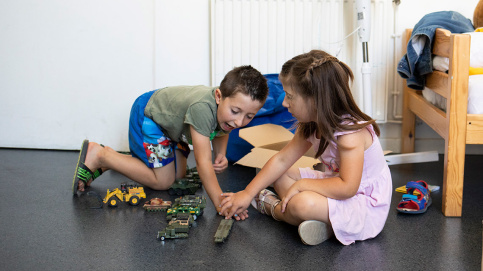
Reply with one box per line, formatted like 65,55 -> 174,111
79,142 -> 175,191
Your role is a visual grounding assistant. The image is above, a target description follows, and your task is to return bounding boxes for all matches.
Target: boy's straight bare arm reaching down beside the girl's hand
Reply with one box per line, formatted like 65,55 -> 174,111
190,126 -> 222,212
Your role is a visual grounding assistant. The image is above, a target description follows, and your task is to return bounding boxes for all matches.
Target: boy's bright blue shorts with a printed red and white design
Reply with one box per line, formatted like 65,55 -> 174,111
129,90 -> 190,168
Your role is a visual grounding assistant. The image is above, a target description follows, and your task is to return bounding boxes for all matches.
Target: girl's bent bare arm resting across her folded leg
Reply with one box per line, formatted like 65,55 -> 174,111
282,129 -> 366,211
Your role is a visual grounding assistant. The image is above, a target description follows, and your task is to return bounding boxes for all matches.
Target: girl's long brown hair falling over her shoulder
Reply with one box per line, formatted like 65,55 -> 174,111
279,50 -> 380,157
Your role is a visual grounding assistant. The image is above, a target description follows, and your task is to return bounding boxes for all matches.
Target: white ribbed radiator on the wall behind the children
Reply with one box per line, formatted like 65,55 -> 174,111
211,0 -> 393,121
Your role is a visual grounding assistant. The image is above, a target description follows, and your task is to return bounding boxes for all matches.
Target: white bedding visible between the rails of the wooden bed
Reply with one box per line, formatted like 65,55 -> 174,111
423,32 -> 483,114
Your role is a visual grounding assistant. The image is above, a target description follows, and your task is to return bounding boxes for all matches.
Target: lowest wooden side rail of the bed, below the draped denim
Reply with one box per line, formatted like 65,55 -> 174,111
408,89 -> 448,139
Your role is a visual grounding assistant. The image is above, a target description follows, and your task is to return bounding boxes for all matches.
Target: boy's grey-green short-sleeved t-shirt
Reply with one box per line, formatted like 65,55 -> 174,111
144,86 -> 225,144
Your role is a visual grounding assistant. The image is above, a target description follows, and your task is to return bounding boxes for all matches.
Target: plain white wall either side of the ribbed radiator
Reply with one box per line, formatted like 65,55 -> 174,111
0,0 -> 478,153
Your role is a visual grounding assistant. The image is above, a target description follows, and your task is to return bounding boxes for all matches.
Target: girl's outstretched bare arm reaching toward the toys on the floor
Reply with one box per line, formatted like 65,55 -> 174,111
221,129 -> 312,218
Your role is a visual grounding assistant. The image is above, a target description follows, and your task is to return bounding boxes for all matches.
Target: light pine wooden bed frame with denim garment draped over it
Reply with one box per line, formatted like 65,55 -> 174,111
402,28 -> 483,217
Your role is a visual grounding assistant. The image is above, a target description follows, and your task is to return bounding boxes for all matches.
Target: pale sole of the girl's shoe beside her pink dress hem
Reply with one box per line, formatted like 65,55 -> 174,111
299,220 -> 334,246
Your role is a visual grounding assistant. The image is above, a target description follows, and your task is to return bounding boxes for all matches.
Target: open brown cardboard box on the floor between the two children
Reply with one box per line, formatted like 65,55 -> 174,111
235,124 -> 320,168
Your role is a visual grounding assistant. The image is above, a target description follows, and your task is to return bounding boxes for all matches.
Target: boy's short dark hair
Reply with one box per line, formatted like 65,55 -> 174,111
220,65 -> 268,103
